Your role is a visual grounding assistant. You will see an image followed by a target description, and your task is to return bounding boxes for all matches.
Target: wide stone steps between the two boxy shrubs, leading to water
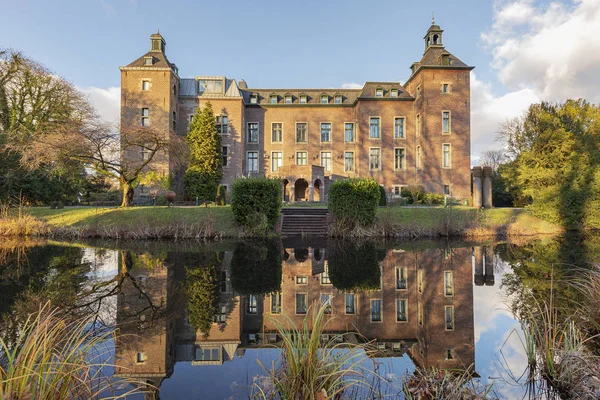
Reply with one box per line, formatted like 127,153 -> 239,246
281,208 -> 329,236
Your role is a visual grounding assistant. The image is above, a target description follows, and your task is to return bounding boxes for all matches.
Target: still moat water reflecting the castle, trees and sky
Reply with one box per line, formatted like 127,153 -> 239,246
0,237 -> 599,399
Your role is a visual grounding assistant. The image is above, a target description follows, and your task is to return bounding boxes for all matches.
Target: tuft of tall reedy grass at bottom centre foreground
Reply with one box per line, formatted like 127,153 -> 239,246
253,302 -> 380,400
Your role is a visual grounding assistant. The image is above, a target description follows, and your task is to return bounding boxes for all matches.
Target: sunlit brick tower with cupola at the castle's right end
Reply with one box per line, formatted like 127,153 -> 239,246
405,19 -> 474,198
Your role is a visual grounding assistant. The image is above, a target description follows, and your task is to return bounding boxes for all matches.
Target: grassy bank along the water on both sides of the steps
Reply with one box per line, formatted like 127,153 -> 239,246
0,205 -> 562,240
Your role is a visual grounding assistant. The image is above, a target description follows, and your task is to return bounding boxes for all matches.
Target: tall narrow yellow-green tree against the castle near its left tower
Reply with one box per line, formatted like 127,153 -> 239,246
185,102 -> 223,201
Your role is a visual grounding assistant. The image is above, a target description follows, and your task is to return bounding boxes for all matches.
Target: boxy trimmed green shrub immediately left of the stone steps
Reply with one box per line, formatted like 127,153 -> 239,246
231,178 -> 281,232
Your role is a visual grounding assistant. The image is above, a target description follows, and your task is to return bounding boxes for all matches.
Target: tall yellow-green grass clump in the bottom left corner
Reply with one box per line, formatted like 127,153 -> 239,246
0,303 -> 145,400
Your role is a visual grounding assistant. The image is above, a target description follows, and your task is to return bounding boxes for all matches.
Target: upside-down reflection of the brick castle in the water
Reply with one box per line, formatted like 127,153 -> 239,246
115,242 -> 494,394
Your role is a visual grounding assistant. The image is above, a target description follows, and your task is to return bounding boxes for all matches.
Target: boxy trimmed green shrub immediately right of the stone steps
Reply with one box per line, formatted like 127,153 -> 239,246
329,178 -> 380,229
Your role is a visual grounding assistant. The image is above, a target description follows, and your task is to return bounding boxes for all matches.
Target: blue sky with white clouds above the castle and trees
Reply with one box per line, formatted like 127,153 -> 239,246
0,0 -> 600,158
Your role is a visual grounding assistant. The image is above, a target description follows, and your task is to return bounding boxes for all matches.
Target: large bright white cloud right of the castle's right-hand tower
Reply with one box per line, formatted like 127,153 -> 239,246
471,0 -> 600,159
